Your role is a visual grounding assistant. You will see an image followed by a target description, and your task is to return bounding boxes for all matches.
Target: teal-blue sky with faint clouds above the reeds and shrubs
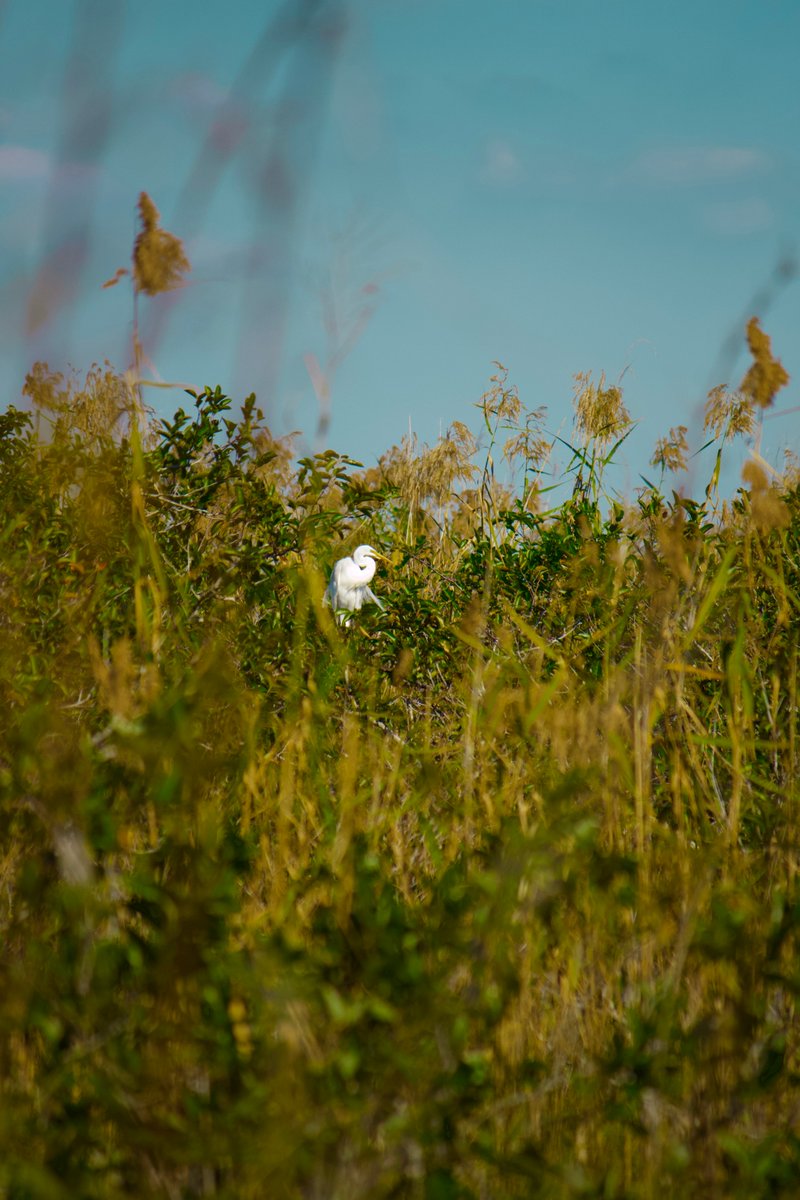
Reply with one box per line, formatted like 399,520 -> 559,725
0,0 -> 800,492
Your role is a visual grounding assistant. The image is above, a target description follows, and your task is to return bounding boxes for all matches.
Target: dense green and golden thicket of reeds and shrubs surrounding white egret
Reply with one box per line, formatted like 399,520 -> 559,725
0,340 -> 800,1200
